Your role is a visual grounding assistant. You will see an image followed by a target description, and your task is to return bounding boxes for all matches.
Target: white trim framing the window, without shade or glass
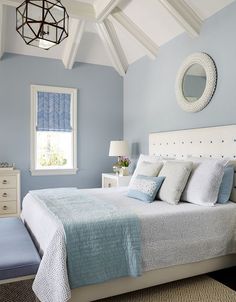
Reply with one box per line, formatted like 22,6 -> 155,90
30,85 -> 78,176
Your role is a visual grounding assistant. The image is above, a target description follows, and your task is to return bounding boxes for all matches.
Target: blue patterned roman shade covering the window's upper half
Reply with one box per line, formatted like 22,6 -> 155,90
36,92 -> 72,132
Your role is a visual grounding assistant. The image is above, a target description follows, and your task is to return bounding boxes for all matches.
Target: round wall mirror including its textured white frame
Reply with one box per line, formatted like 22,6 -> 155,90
176,53 -> 217,112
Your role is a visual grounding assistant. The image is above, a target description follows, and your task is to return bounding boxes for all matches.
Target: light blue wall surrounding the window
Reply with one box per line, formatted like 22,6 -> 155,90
0,54 -> 123,196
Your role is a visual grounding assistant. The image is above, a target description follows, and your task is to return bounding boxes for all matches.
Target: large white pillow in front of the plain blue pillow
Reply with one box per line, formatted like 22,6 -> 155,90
181,158 -> 228,206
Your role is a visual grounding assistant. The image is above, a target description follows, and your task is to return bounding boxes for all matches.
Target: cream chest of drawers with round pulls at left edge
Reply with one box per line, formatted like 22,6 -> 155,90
0,169 -> 20,217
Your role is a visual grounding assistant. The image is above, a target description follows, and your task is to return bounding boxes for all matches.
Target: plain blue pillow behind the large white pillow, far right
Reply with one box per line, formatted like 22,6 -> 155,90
217,166 -> 234,204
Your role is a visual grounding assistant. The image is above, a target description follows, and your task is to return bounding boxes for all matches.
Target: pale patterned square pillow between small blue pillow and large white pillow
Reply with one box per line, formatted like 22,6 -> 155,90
158,160 -> 193,204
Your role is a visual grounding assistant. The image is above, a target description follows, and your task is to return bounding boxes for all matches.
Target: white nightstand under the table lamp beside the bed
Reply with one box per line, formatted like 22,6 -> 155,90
102,173 -> 132,188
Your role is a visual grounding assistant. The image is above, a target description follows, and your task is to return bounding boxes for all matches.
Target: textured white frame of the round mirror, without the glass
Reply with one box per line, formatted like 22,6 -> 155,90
175,52 -> 217,112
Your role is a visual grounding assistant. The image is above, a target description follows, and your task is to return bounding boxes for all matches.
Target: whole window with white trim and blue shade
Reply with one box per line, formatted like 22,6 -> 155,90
31,85 -> 77,175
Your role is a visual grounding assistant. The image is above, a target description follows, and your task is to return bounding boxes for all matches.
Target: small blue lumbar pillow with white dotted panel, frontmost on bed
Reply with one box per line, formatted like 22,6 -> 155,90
127,175 -> 165,202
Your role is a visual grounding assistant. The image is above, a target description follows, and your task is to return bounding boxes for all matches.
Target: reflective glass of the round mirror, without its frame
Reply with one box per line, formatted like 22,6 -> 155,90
182,64 -> 206,102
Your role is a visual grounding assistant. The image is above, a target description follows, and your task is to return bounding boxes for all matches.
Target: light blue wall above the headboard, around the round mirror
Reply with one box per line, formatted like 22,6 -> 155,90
124,2 -> 236,157
